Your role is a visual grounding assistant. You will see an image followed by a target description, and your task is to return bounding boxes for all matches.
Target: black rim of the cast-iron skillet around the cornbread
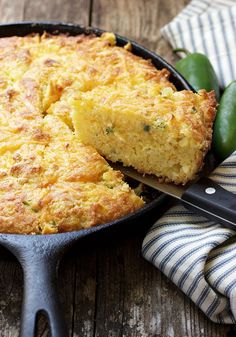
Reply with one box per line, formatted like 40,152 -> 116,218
0,21 -> 194,237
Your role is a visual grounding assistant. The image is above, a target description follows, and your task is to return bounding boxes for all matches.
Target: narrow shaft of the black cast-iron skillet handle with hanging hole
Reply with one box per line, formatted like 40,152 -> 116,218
20,250 -> 69,337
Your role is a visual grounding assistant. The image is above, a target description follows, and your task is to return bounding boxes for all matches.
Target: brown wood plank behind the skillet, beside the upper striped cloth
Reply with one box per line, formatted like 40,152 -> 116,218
92,0 -> 189,61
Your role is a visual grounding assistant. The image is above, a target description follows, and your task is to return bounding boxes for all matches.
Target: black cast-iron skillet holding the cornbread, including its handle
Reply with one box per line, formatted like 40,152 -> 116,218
0,22 -> 192,337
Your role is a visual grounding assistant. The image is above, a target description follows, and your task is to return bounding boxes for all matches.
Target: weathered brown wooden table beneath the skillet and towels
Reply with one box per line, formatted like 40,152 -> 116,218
0,0 -> 235,337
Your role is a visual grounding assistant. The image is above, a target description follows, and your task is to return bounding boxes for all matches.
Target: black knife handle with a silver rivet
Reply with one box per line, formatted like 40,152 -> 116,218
181,178 -> 236,229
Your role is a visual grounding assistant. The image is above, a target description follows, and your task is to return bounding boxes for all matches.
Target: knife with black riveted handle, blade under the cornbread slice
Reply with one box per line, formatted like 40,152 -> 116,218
111,163 -> 236,230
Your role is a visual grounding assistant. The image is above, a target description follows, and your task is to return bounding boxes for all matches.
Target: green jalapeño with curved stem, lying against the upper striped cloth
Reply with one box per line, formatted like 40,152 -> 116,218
174,49 -> 220,100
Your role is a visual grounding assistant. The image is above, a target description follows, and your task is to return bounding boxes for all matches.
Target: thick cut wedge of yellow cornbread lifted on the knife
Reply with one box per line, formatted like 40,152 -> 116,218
73,83 -> 216,184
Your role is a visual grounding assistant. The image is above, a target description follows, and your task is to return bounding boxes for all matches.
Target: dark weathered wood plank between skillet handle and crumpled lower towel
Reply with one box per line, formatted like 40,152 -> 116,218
91,235 -> 229,337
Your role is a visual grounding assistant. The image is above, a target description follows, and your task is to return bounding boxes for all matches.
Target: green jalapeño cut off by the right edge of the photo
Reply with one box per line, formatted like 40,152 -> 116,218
213,81 -> 236,160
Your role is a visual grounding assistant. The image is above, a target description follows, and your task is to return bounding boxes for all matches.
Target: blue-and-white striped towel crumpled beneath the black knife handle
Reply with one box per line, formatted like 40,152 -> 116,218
142,152 -> 236,324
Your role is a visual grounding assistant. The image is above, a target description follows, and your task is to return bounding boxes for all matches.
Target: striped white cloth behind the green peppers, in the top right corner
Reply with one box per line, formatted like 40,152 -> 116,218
161,0 -> 236,87
